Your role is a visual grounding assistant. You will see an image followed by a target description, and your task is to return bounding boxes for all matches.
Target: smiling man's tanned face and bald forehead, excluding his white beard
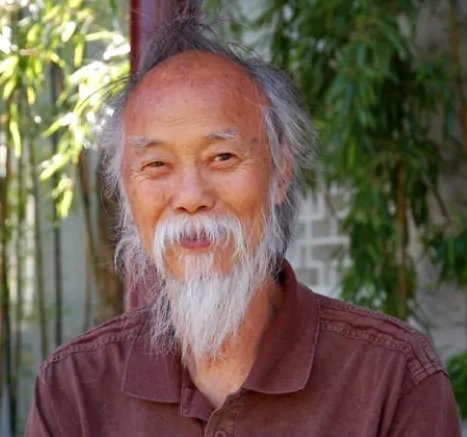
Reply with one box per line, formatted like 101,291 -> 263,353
122,52 -> 271,279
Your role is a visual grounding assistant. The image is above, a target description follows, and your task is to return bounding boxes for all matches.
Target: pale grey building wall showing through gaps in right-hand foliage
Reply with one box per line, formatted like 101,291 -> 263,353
287,190 -> 467,359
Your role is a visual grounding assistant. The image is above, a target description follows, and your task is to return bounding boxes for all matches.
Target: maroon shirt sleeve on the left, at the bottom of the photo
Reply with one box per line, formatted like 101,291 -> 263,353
25,377 -> 62,437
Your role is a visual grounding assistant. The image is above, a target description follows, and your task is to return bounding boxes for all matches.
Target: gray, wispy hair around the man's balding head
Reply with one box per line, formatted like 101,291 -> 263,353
101,16 -> 316,278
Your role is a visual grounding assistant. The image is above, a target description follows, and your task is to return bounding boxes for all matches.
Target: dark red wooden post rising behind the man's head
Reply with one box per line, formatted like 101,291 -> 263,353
125,0 -> 201,310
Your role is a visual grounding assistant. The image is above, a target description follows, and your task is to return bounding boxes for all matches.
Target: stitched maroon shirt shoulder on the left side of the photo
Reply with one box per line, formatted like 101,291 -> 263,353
38,310 -> 147,379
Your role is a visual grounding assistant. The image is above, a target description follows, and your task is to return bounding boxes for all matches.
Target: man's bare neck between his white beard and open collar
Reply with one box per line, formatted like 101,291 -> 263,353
188,280 -> 283,408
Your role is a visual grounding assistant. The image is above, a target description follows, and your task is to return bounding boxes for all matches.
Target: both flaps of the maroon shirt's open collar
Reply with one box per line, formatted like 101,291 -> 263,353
122,261 -> 318,403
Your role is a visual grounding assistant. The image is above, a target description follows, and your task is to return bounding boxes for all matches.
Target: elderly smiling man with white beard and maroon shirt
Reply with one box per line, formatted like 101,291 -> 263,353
27,17 -> 460,437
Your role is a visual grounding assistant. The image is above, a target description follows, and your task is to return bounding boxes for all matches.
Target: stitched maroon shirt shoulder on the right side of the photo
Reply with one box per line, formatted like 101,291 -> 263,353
308,288 -> 444,385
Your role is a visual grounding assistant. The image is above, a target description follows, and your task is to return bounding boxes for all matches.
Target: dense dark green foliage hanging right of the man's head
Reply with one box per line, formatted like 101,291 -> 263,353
206,0 -> 464,318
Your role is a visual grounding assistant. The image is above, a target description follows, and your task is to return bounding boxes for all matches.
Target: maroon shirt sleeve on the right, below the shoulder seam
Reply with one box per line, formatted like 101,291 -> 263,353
388,372 -> 462,437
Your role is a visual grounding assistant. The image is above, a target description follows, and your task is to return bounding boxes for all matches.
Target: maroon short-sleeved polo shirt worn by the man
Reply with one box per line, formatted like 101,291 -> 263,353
26,265 -> 461,437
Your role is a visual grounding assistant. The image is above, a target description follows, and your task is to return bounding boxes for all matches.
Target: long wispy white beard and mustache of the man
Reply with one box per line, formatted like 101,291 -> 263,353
152,215 -> 272,364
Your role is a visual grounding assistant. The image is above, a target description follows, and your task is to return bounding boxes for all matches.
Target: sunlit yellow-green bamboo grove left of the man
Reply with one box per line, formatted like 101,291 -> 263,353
0,0 -> 129,435
